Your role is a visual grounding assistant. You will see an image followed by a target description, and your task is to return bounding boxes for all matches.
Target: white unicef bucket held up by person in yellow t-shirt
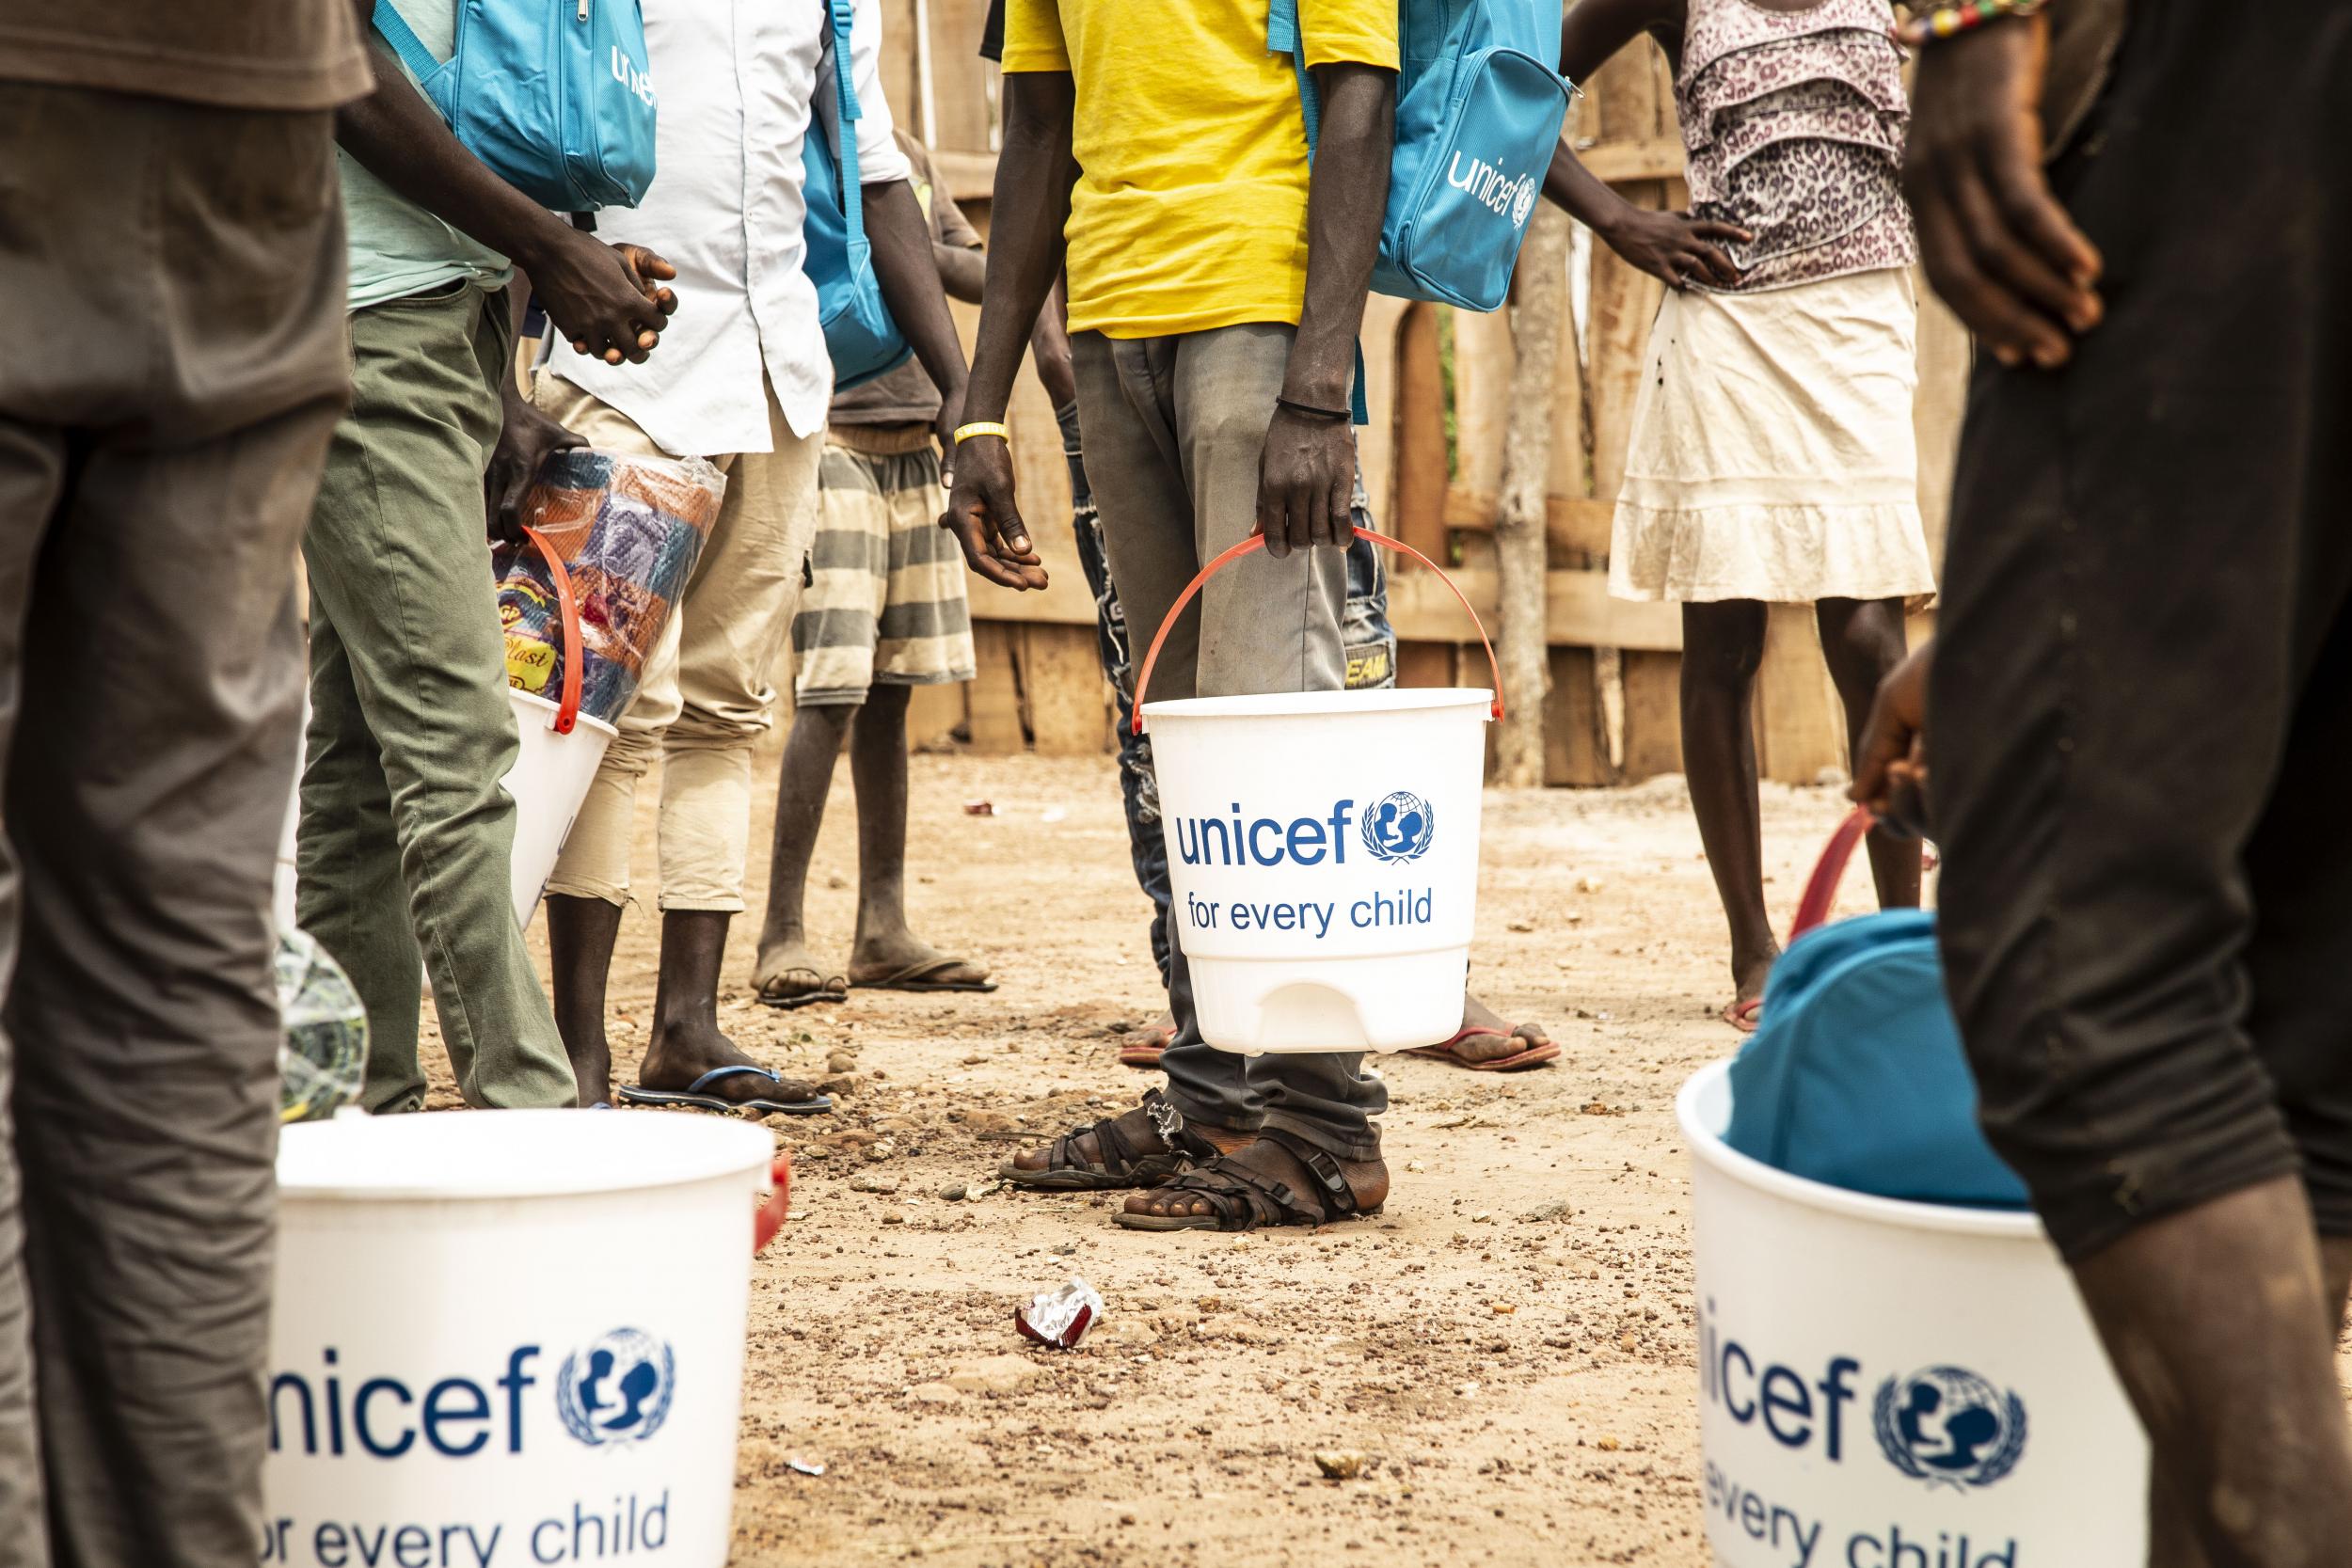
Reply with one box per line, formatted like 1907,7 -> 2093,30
1136,531 -> 1501,1053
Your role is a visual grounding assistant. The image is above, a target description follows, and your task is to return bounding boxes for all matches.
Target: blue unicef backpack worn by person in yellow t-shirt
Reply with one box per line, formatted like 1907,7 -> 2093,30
1265,0 -> 1569,310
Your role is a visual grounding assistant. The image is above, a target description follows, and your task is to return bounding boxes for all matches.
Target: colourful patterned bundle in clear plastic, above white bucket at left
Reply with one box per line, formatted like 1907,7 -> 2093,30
497,449 -> 727,724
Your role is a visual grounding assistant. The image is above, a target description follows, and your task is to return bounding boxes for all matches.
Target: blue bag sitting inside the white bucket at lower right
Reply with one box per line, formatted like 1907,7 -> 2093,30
1724,811 -> 2026,1209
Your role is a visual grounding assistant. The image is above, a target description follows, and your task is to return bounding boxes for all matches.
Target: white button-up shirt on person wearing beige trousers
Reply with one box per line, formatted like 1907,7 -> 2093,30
546,0 -> 908,456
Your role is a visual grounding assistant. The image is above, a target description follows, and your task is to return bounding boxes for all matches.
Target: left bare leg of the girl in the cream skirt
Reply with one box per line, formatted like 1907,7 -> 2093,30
1682,599 -> 1781,1020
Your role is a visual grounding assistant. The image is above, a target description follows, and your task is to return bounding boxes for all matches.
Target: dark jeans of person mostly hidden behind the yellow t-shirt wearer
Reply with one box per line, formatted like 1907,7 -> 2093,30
1071,486 -> 1397,985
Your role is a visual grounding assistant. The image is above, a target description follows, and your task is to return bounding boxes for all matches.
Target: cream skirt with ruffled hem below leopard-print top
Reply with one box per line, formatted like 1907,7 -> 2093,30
1609,268 -> 1936,602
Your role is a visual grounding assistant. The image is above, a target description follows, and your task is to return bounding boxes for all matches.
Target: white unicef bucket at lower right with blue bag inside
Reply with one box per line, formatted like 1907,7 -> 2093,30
1675,1063 -> 2148,1568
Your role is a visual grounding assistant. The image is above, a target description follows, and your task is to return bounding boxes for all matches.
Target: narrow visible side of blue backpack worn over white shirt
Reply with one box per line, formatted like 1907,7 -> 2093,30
800,0 -> 908,392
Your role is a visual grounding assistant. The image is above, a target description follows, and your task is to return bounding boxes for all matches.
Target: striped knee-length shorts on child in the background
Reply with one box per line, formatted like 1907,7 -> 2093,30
793,425 -> 974,707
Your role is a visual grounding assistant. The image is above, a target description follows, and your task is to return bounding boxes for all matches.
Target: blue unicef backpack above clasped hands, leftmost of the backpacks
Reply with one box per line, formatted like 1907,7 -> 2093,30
374,0 -> 654,212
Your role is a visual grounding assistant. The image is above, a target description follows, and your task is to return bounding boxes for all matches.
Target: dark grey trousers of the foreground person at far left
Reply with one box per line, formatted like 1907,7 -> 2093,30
0,82 -> 343,1568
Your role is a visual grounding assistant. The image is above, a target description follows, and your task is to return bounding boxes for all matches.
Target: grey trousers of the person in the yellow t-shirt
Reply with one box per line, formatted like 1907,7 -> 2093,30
1071,325 -> 1388,1159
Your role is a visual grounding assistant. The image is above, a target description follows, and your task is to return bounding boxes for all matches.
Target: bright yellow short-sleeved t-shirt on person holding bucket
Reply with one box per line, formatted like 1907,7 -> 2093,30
1005,0 -> 1397,339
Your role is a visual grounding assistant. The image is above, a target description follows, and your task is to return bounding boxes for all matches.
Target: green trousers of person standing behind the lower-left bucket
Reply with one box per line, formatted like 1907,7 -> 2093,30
296,282 -> 577,1112
